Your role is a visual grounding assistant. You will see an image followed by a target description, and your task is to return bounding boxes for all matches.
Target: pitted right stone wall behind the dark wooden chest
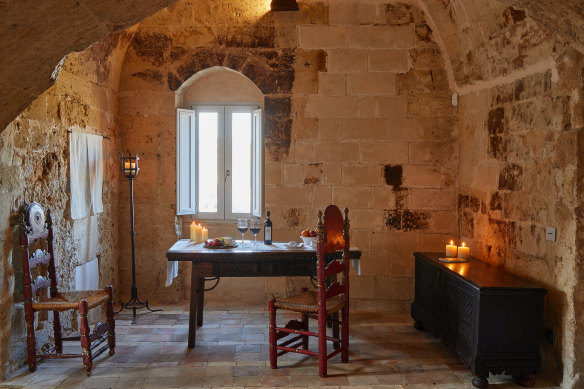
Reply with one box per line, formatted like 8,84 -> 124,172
452,2 -> 584,387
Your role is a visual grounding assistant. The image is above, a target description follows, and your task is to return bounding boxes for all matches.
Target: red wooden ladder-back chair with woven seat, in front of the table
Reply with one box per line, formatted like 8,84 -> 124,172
268,205 -> 350,377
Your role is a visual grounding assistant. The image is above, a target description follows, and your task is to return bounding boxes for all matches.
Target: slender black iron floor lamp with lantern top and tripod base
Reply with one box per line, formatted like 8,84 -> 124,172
116,153 -> 162,324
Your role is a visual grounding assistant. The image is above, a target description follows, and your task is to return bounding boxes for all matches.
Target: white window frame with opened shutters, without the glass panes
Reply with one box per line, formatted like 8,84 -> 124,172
177,103 -> 264,220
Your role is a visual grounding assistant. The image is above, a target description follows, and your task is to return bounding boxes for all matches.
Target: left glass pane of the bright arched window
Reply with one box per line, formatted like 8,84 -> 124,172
198,112 -> 219,212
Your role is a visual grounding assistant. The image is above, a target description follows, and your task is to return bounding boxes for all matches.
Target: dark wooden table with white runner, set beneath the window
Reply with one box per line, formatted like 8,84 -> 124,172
166,239 -> 361,348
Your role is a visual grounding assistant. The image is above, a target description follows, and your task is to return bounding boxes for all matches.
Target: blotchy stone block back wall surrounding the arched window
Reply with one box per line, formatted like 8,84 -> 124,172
119,0 -> 457,308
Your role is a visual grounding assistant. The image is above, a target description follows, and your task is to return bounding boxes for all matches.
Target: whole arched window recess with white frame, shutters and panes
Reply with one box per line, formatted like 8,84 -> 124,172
177,67 -> 264,220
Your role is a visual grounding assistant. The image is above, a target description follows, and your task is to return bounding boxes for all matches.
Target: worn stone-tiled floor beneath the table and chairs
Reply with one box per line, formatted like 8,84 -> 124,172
0,303 -> 555,389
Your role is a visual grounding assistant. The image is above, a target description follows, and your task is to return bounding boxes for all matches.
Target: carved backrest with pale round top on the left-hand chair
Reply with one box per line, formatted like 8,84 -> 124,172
20,202 -> 58,304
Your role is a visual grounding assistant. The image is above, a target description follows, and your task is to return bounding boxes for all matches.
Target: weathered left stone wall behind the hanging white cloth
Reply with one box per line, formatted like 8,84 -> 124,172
0,32 -> 130,380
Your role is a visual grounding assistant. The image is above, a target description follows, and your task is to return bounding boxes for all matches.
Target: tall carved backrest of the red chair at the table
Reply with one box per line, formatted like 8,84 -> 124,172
316,205 -> 350,304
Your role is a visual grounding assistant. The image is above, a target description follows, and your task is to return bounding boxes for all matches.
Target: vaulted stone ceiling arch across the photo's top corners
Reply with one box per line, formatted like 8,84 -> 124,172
0,0 -> 584,132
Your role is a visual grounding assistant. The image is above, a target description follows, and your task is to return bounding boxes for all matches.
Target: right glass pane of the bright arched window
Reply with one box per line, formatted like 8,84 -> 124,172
231,112 -> 251,213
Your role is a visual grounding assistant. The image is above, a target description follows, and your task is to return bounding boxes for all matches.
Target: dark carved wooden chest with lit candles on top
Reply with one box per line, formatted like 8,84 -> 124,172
411,253 -> 546,388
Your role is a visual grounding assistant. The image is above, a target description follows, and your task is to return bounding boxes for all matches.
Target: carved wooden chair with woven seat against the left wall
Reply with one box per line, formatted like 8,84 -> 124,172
20,203 -> 116,375
